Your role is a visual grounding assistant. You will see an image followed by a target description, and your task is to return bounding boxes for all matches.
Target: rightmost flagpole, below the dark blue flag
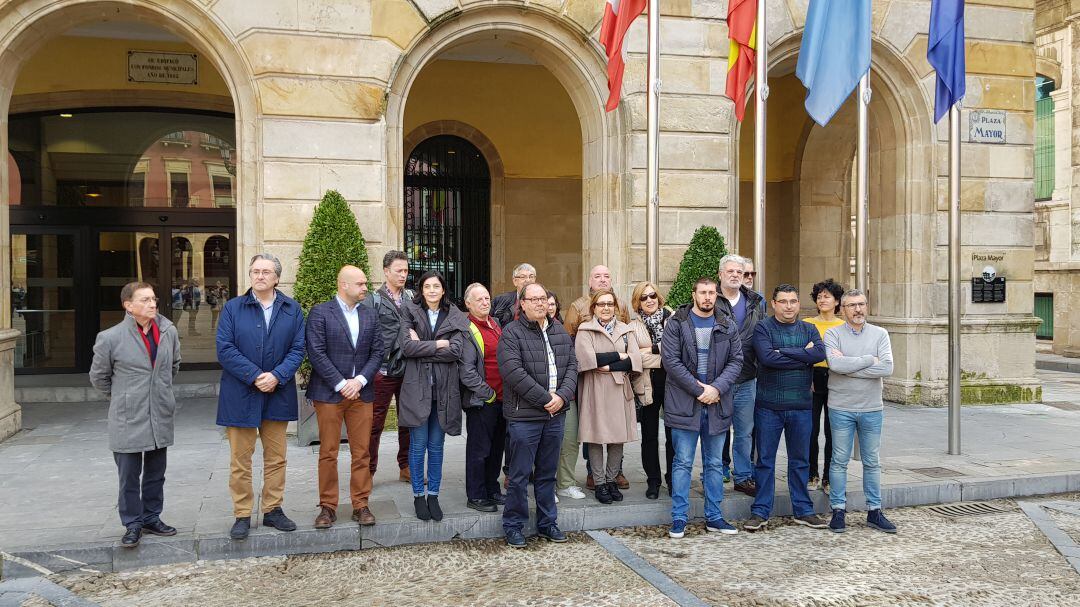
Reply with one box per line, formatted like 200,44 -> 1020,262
948,102 -> 961,455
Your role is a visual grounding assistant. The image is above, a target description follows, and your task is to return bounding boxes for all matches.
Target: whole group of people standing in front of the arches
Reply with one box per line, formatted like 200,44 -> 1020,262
90,251 -> 896,548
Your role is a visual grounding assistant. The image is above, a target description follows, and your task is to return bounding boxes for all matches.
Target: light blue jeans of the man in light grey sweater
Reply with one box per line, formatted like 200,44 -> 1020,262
828,409 -> 885,510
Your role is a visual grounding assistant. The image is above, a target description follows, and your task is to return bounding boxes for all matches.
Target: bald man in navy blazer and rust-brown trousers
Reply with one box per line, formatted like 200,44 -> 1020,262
307,266 -> 383,529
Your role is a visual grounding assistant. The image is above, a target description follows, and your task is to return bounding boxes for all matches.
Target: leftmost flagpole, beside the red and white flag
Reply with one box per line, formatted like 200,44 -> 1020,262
645,0 -> 660,284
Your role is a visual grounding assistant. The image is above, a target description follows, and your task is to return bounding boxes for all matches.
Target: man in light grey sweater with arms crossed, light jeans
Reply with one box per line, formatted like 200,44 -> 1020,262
824,288 -> 896,534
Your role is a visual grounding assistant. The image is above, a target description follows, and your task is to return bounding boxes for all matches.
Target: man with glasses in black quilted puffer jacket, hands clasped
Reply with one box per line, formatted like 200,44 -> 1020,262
497,283 -> 578,548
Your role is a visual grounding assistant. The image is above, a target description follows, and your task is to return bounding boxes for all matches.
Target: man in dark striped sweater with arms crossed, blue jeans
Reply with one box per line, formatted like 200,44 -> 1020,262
743,284 -> 828,531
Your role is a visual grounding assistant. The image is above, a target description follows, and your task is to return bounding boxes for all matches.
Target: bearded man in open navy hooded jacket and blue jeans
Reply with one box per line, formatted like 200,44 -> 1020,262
660,276 -> 743,538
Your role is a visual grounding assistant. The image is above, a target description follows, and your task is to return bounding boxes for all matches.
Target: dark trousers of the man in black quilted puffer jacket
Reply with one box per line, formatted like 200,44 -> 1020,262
502,415 -> 566,531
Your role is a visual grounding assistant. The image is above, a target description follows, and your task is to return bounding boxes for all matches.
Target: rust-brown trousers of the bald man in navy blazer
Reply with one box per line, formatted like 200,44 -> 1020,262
314,400 -> 373,512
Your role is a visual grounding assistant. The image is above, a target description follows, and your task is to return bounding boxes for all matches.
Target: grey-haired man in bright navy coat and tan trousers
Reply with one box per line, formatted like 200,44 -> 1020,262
217,253 -> 303,540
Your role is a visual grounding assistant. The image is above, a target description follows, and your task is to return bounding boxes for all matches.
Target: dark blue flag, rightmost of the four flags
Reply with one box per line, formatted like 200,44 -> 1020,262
927,0 -> 968,122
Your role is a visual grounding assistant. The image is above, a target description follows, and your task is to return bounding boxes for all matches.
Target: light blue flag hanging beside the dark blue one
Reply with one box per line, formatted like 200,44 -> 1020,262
795,0 -> 870,126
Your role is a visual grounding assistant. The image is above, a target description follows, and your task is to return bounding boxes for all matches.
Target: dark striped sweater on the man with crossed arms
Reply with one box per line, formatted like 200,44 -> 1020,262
754,316 -> 825,410
